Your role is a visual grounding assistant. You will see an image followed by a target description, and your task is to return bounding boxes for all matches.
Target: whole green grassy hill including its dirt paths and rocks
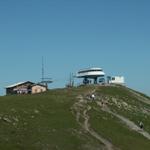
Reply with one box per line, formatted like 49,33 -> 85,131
0,86 -> 150,150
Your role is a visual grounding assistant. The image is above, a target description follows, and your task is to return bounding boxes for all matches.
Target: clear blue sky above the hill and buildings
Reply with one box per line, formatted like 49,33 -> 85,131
0,0 -> 150,95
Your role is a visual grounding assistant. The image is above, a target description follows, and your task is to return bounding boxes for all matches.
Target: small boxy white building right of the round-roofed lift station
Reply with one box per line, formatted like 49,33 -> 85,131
107,76 -> 125,85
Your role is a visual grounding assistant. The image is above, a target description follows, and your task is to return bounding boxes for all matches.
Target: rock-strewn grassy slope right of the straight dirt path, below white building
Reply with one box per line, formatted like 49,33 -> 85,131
97,86 -> 150,133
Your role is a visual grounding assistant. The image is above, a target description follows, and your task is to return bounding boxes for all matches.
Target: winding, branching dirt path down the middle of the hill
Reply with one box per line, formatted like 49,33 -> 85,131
73,96 -> 113,150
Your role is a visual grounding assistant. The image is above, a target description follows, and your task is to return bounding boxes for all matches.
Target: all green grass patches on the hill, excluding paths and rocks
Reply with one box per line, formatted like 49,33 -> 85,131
0,86 -> 150,150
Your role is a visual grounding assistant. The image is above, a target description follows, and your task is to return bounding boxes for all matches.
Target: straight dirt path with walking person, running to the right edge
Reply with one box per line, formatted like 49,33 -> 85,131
97,101 -> 150,140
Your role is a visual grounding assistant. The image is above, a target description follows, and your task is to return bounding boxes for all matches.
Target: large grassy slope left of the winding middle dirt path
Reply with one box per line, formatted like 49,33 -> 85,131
0,89 -> 101,150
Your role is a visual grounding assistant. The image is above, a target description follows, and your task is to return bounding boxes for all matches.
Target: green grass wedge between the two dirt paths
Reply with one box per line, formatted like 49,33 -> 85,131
90,106 -> 150,150
